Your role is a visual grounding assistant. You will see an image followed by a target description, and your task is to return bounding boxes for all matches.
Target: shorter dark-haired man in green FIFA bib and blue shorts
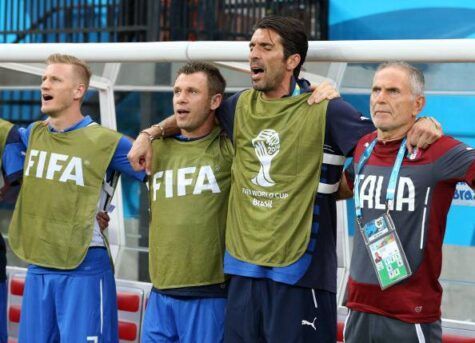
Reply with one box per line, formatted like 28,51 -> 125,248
142,62 -> 233,343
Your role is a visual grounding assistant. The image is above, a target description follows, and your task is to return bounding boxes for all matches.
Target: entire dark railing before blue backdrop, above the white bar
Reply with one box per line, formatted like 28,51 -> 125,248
0,0 -> 328,43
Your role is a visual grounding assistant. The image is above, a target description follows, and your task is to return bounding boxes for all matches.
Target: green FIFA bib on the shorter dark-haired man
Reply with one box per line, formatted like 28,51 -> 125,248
149,128 -> 233,289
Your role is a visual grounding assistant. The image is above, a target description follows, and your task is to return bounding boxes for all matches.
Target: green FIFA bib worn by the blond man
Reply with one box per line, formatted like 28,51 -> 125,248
9,122 -> 121,269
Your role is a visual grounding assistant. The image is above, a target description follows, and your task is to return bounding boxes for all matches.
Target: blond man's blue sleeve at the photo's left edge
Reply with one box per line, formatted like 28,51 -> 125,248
2,126 -> 25,183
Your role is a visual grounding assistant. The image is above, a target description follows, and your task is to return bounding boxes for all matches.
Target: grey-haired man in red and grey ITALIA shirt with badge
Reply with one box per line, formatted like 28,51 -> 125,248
344,62 -> 475,343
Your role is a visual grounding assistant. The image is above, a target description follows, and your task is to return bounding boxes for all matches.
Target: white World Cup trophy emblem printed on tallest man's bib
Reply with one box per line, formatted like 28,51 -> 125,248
251,129 -> 280,187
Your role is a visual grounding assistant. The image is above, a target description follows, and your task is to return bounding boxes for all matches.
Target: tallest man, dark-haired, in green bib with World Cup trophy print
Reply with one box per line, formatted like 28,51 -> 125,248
220,17 -> 372,342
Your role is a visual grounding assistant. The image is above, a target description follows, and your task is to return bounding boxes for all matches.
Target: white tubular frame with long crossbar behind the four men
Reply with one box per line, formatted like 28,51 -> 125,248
0,39 -> 475,336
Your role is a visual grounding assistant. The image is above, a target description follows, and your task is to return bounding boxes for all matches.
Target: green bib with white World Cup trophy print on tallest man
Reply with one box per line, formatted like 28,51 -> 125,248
226,90 -> 328,267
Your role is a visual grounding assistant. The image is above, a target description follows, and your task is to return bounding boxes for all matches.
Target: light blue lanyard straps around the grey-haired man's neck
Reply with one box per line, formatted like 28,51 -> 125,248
354,138 -> 406,223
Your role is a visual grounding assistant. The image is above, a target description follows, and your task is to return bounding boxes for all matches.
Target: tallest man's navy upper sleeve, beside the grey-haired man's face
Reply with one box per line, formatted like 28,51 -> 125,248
326,98 -> 376,156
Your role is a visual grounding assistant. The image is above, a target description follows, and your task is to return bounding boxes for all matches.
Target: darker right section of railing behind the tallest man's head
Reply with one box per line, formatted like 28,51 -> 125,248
161,0 -> 328,40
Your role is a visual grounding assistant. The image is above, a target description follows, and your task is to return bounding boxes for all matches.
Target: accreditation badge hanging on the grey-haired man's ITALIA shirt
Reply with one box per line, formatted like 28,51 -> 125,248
360,213 -> 412,290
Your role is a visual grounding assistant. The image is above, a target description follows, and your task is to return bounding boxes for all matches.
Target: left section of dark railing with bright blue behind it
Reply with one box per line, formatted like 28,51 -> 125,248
0,0 -> 152,43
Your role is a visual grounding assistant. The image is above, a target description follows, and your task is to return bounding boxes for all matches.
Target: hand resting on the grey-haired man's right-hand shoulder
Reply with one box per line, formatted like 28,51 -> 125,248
406,117 -> 443,153
